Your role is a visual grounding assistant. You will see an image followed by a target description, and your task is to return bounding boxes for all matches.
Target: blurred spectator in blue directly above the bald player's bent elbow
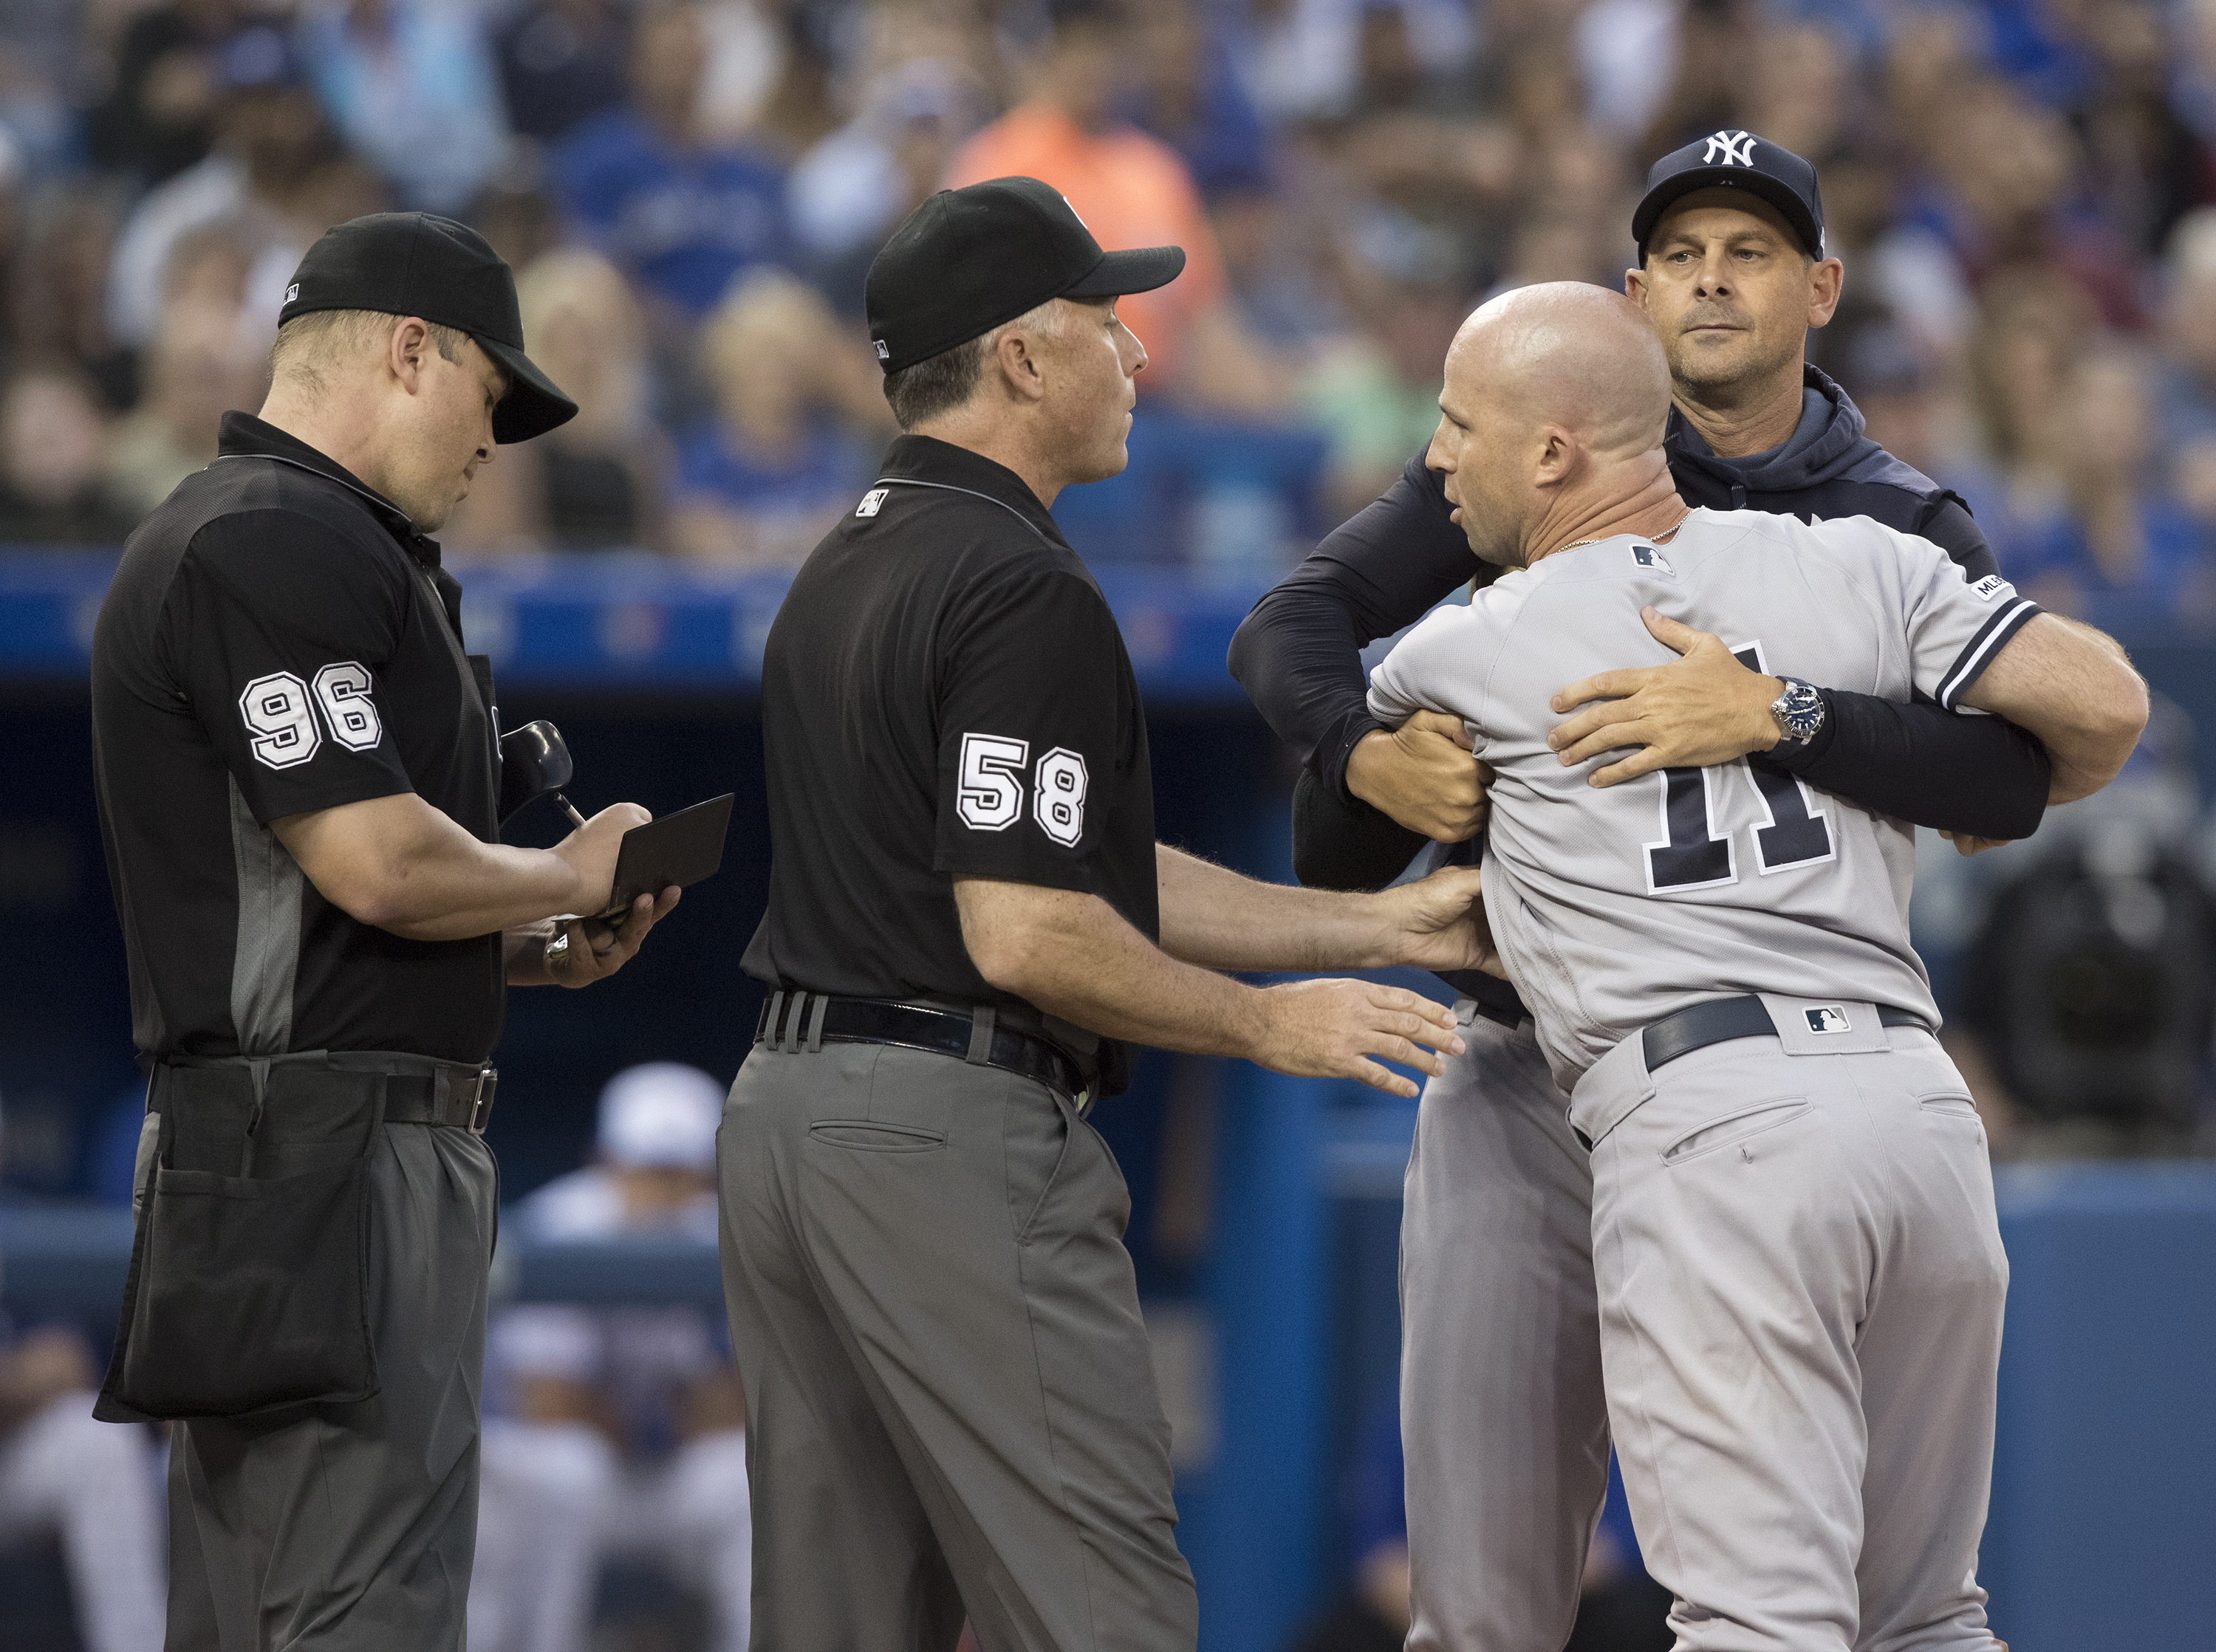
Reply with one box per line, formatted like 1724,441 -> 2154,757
2003,348 -> 2209,625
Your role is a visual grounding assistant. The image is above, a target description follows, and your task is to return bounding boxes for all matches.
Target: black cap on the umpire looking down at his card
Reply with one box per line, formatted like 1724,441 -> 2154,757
277,213 -> 576,443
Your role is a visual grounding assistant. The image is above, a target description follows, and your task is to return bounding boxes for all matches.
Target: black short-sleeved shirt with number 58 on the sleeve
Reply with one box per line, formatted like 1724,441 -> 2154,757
745,436 -> 1159,1005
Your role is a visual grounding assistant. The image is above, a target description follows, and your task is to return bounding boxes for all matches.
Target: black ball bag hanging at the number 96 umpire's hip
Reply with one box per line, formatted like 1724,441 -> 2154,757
93,1054 -> 386,1422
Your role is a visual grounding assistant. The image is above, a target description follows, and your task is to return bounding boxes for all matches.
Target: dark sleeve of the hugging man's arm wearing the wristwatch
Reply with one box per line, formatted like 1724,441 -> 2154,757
1768,494 -> 2054,839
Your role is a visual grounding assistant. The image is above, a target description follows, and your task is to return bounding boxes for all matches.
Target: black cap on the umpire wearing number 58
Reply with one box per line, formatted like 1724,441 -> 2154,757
864,177 -> 1186,372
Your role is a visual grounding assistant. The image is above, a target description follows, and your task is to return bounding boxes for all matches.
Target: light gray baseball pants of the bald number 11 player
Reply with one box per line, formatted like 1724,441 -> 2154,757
1571,998 -> 2008,1652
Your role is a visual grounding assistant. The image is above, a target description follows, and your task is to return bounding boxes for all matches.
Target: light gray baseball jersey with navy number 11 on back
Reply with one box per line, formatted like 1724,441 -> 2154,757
1369,510 -> 2039,1089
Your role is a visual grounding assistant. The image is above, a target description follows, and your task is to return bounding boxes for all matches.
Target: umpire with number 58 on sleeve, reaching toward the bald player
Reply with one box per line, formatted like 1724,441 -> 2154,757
718,177 -> 1485,1652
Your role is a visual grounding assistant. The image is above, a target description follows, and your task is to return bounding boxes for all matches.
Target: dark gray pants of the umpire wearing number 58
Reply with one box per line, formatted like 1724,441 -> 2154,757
718,1023 -> 1197,1652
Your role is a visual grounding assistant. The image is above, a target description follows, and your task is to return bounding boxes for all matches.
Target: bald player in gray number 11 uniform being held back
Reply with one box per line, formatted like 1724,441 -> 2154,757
1369,284 -> 2147,1652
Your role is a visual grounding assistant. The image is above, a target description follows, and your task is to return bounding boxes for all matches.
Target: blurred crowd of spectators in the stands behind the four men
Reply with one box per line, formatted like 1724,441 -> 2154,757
0,0 -> 2216,597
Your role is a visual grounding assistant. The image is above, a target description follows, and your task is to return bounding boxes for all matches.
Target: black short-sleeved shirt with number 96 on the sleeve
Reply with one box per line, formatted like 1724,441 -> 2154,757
93,412 -> 505,1060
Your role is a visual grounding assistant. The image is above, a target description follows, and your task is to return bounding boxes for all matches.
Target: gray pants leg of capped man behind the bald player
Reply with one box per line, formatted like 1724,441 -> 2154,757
1401,998 -> 1609,1652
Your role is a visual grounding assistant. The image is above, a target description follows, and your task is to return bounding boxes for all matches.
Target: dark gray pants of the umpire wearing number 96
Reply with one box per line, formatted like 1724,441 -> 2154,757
166,1125 -> 499,1652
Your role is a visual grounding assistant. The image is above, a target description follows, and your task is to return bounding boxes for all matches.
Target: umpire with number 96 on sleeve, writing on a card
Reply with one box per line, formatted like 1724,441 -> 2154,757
93,213 -> 676,1652
